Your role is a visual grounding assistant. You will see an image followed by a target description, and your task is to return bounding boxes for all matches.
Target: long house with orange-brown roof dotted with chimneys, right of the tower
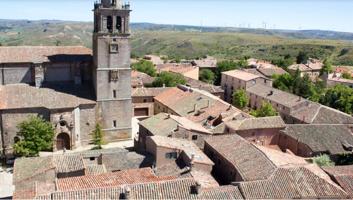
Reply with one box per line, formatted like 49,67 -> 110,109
154,86 -> 251,129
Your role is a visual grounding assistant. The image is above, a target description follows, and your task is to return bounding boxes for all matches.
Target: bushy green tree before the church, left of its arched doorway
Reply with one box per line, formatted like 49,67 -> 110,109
14,117 -> 54,157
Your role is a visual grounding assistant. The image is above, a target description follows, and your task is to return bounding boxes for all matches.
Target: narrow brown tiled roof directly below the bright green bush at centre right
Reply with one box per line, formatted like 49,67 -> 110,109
225,116 -> 286,131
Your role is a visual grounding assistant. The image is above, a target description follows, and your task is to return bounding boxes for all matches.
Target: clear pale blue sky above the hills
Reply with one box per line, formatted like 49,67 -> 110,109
0,0 -> 353,32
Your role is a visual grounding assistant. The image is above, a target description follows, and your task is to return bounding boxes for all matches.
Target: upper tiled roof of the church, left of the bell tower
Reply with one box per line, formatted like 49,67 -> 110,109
0,46 -> 92,63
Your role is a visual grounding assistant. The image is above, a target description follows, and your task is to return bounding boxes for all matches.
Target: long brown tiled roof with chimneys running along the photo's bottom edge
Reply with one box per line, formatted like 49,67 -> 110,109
37,178 -> 242,200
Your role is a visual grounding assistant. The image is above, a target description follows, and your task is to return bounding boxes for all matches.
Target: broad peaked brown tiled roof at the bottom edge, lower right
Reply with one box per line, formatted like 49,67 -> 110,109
239,167 -> 347,199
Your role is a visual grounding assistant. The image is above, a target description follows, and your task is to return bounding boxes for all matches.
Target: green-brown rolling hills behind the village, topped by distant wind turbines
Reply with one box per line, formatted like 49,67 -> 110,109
0,20 -> 353,65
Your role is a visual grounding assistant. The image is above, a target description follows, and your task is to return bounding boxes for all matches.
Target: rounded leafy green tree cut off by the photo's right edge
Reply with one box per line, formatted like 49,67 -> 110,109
320,85 -> 353,114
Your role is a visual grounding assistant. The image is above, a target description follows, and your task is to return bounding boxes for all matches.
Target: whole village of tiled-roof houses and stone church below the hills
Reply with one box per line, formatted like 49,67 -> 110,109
0,0 -> 353,200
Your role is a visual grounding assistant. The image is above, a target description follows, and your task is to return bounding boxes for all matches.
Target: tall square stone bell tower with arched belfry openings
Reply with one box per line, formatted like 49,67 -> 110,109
93,0 -> 132,142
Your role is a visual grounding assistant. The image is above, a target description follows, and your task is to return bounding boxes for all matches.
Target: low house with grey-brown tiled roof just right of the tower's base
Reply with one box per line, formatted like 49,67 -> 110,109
137,113 -> 212,149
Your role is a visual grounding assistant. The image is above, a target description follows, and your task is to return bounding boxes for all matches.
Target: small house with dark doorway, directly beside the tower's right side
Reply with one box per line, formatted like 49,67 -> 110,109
131,87 -> 170,117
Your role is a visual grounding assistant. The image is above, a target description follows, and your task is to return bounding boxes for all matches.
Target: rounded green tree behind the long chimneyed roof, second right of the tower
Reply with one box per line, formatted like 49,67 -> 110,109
152,72 -> 186,87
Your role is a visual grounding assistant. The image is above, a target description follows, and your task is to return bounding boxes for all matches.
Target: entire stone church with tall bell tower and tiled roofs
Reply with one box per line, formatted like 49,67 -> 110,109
0,0 -> 132,155
